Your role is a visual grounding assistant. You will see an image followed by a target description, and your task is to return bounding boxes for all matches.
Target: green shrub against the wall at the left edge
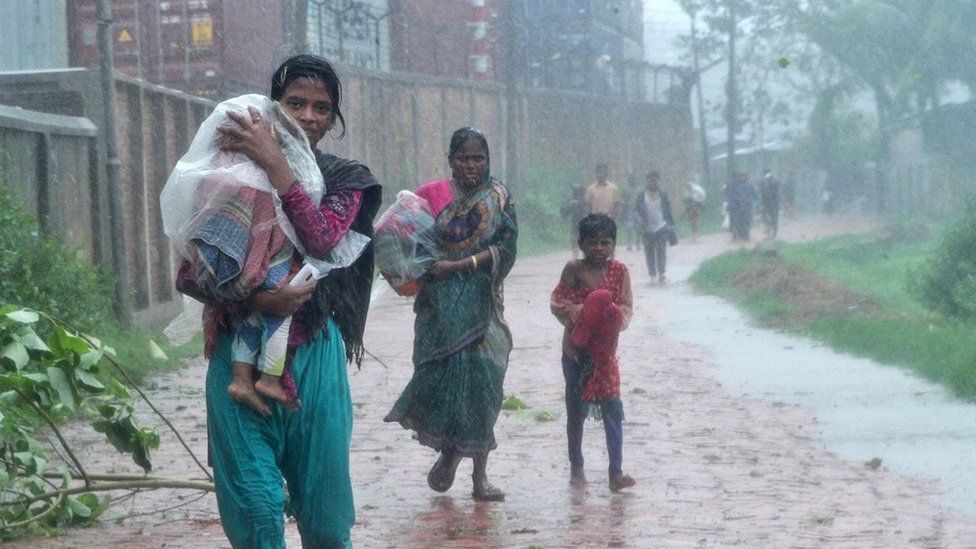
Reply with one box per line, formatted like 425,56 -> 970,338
0,178 -> 114,330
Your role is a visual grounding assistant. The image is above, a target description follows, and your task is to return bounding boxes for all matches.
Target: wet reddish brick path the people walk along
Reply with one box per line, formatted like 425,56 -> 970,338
12,216 -> 976,547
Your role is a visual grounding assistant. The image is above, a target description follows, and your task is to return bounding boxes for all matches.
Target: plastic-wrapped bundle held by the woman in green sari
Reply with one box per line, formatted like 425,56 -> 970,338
374,191 -> 437,295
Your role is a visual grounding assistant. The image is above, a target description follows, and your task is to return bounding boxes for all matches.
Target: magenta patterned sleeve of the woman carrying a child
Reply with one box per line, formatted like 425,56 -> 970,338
281,182 -> 363,259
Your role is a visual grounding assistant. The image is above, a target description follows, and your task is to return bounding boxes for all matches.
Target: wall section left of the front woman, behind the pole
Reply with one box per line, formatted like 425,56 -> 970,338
0,69 -> 213,323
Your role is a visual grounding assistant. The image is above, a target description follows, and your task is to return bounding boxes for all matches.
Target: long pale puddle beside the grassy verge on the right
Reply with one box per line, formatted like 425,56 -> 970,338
643,272 -> 976,516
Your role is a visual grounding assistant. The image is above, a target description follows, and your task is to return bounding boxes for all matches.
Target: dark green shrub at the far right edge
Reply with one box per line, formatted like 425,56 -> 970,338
909,203 -> 976,321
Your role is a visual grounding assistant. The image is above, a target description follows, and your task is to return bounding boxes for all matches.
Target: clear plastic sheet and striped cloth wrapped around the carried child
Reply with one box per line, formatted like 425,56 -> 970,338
159,94 -> 369,300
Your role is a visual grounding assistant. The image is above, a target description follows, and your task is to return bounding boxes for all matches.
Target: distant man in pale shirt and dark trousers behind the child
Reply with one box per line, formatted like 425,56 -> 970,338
634,171 -> 674,284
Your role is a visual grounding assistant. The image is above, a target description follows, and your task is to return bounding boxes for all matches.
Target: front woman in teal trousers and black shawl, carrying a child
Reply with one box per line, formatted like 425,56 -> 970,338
170,55 -> 381,547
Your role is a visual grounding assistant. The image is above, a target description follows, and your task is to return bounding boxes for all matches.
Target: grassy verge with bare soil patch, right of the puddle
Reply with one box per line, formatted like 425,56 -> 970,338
691,225 -> 976,399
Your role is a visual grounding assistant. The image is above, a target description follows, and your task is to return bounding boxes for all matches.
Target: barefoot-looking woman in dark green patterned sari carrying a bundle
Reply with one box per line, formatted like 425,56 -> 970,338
385,128 -> 518,501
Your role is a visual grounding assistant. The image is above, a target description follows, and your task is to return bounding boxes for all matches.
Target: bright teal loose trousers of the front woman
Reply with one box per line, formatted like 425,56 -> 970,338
206,319 -> 356,549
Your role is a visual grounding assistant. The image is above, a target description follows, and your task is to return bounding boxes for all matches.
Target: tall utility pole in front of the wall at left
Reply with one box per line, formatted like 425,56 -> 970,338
96,0 -> 130,323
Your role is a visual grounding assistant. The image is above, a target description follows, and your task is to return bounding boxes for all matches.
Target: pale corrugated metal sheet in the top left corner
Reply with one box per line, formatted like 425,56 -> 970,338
0,0 -> 68,71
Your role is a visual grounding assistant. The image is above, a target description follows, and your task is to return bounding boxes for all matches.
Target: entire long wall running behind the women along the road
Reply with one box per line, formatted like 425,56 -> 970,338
0,67 -> 692,323
